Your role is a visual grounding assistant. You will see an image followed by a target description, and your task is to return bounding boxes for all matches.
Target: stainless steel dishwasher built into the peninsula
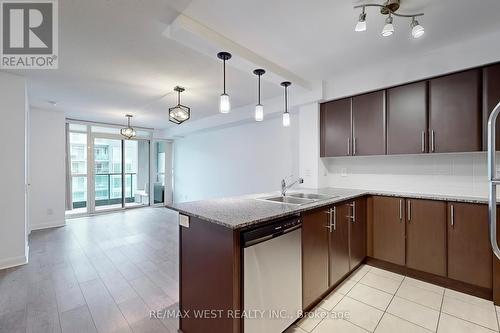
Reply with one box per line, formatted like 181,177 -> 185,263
242,217 -> 302,333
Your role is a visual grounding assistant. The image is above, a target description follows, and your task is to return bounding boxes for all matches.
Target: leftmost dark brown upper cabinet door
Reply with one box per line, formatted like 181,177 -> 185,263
321,98 -> 351,157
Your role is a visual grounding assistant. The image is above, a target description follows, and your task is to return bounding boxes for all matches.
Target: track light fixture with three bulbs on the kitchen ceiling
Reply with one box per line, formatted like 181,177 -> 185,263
354,0 -> 425,38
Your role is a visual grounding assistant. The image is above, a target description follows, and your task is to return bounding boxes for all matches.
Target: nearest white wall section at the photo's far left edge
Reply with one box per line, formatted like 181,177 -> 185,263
0,72 -> 28,269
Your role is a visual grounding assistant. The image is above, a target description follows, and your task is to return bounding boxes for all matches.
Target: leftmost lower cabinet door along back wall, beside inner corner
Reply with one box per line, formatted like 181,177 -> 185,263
371,196 -> 405,265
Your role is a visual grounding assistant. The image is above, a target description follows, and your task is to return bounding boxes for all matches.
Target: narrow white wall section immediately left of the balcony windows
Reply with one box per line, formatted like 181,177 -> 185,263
29,109 -> 66,230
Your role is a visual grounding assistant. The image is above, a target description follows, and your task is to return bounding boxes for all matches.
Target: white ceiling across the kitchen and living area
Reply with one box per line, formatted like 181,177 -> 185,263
5,0 -> 500,128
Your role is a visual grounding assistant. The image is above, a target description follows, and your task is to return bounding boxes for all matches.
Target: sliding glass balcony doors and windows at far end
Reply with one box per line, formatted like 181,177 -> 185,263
66,123 -> 172,216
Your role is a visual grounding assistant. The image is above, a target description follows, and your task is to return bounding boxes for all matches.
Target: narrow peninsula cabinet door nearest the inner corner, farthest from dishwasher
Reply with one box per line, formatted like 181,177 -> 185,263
349,198 -> 366,270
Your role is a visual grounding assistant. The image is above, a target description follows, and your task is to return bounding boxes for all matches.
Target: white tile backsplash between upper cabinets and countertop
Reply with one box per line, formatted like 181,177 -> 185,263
321,152 -> 500,197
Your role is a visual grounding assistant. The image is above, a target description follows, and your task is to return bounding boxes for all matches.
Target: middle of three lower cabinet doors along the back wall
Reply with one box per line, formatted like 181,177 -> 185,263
406,199 -> 446,276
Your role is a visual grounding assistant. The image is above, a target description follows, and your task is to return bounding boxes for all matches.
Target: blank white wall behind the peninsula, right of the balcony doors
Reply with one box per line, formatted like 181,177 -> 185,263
174,113 -> 298,202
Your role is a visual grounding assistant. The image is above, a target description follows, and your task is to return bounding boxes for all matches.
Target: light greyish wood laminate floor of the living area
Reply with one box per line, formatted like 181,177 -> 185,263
0,208 -> 179,333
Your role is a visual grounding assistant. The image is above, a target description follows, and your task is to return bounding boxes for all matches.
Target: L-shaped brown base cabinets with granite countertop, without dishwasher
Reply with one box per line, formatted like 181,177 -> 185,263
169,188 -> 500,333
